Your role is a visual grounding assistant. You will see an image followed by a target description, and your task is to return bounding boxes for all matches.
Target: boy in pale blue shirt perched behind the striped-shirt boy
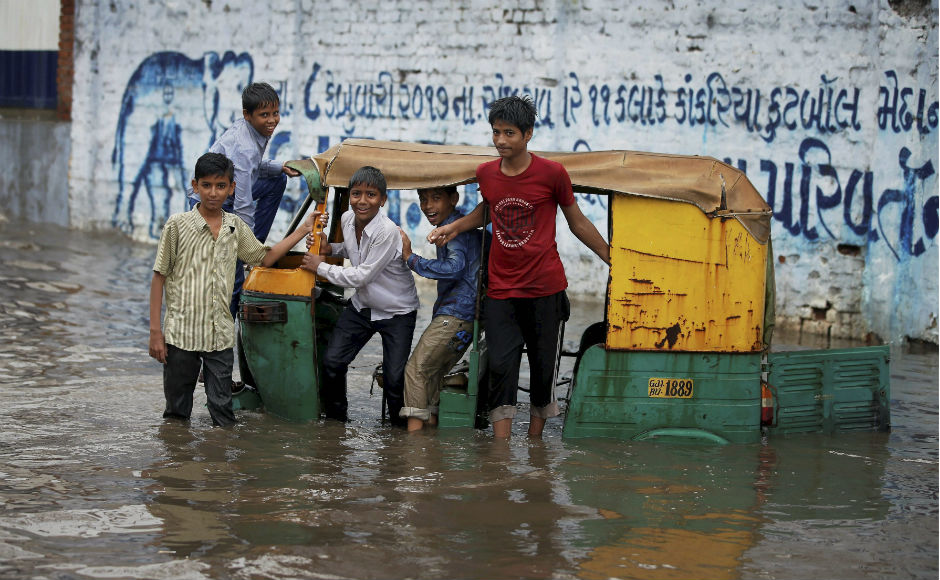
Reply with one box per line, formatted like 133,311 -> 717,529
189,83 -> 300,318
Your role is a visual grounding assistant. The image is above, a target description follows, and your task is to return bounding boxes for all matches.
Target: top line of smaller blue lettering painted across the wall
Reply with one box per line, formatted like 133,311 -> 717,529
303,63 -> 940,143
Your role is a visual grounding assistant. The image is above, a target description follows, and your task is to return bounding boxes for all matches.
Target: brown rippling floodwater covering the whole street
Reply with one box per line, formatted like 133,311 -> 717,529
0,223 -> 938,580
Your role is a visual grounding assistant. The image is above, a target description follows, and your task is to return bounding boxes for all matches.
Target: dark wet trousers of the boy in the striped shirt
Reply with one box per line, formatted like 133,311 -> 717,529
163,344 -> 235,427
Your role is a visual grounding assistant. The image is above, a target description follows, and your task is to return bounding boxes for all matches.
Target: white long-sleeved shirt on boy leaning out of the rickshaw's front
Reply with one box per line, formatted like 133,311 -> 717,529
317,210 -> 420,320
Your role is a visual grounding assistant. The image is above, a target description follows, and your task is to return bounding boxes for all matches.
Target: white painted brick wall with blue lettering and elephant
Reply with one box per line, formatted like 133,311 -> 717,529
70,0 -> 940,342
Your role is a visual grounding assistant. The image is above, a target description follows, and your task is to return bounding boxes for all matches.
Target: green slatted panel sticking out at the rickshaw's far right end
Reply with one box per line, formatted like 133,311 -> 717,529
767,345 -> 891,433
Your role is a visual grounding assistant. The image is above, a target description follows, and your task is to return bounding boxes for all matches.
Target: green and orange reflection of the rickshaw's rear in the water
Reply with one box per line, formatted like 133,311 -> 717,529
566,434 -> 889,579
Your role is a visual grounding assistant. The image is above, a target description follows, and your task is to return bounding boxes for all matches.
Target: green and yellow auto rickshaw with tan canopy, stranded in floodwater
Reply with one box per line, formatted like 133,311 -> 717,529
229,139 -> 890,443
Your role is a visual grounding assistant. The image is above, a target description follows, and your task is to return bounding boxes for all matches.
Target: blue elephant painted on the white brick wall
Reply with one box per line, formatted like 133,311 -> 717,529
111,52 -> 254,237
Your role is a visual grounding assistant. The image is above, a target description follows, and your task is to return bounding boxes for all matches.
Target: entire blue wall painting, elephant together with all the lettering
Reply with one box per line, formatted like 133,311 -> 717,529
113,52 -> 940,261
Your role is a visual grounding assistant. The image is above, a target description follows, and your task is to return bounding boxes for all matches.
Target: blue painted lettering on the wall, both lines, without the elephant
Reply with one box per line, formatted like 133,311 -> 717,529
303,63 -> 940,260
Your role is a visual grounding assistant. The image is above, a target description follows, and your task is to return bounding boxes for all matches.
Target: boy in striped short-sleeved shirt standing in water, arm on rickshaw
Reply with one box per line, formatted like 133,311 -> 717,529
150,153 -> 318,427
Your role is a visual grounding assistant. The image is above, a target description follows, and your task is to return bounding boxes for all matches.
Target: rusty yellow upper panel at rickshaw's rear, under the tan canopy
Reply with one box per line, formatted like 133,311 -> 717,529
607,195 -> 767,352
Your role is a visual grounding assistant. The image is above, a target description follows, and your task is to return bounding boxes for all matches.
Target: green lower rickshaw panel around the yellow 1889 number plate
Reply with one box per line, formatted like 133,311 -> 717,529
563,345 -> 760,443
